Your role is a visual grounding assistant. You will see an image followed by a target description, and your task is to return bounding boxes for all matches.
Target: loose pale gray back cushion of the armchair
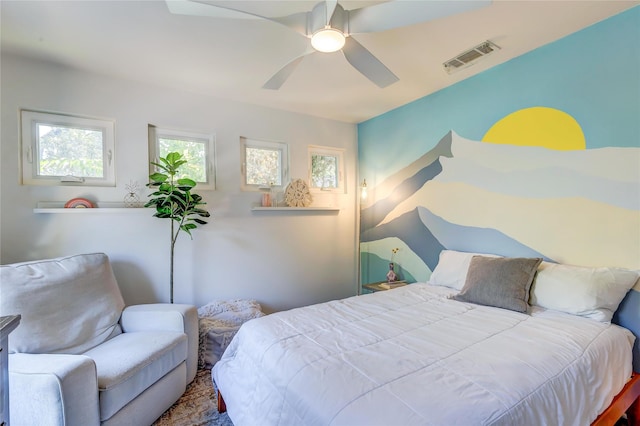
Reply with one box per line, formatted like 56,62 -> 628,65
0,253 -> 124,354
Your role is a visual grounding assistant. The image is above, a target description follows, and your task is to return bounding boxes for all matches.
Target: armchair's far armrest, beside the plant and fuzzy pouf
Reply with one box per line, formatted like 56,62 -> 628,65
120,303 -> 199,383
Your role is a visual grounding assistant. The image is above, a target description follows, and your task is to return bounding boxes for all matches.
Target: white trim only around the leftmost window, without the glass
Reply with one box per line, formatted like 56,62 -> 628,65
20,109 -> 116,186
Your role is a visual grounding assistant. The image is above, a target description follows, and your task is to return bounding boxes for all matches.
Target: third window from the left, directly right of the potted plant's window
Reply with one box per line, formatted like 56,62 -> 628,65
240,138 -> 289,191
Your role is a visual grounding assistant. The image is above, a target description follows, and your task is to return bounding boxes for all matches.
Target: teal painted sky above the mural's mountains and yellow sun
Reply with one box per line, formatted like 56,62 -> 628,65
358,6 -> 640,182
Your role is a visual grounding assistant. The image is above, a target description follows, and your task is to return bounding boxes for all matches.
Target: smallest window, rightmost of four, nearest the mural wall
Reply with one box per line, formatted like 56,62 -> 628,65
309,145 -> 345,193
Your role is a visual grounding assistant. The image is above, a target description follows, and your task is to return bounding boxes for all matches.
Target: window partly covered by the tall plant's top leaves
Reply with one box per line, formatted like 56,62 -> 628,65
149,125 -> 216,190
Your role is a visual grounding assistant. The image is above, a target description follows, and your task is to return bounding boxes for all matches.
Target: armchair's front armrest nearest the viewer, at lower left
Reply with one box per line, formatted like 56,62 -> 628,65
9,353 -> 100,426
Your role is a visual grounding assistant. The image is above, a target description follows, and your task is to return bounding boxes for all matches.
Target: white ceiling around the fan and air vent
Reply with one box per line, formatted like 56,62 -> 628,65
0,0 -> 640,123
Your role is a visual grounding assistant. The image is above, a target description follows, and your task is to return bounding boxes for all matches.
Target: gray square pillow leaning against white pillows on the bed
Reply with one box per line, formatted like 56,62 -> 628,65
453,256 -> 542,312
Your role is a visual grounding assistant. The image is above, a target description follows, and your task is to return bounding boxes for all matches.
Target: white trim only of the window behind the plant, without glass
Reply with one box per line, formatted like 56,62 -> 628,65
149,124 -> 216,191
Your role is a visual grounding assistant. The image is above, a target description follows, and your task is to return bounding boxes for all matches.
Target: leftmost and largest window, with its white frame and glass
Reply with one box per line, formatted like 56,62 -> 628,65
20,110 -> 116,186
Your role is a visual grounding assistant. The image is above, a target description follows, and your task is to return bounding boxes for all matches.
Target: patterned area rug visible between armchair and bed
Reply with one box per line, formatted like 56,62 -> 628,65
153,369 -> 233,426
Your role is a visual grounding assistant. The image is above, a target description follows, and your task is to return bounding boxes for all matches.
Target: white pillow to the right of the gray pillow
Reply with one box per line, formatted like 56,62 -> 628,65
529,262 -> 640,323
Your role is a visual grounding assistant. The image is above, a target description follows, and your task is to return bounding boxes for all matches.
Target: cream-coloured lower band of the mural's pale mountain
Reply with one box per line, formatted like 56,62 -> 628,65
421,181 -> 640,268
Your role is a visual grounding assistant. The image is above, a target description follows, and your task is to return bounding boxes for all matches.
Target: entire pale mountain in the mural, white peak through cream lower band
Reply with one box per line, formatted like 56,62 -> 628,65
382,131 -> 640,269
